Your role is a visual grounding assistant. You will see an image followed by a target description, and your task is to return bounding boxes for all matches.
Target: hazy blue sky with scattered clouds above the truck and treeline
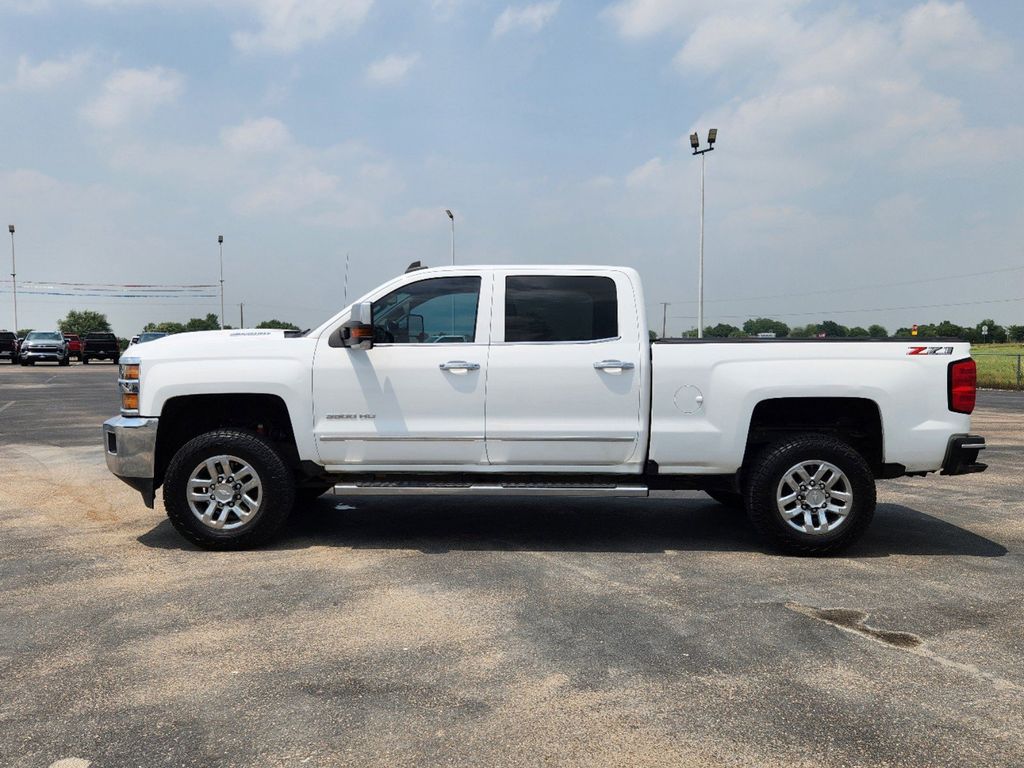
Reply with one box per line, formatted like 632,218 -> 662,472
0,0 -> 1024,335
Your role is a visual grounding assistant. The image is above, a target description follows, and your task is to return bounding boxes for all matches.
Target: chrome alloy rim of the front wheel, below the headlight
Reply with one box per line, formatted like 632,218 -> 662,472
186,456 -> 263,530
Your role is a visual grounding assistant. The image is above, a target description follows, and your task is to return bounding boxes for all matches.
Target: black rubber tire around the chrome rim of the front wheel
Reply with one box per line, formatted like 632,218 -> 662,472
164,429 -> 295,550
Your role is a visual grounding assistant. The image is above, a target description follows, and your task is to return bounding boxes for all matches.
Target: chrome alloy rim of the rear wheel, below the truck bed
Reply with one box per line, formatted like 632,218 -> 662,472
775,460 -> 853,535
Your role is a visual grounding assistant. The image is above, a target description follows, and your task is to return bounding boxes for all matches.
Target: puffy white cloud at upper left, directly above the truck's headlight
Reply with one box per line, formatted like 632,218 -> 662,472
82,67 -> 184,128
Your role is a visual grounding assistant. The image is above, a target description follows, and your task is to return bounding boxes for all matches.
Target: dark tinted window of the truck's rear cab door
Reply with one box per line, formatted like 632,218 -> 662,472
505,274 -> 618,341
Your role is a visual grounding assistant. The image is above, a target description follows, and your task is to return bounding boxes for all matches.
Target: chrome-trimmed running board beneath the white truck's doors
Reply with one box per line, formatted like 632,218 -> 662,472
334,482 -> 649,497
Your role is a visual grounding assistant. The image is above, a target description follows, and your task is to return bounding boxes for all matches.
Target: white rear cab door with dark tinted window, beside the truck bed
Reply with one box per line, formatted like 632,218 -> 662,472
486,269 -> 644,472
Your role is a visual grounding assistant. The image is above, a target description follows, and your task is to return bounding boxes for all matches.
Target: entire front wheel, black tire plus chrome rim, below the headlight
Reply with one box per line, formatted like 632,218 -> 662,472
164,429 -> 295,550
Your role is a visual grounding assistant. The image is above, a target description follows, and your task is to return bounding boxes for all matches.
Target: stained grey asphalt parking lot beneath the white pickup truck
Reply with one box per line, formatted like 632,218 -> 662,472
0,365 -> 1024,768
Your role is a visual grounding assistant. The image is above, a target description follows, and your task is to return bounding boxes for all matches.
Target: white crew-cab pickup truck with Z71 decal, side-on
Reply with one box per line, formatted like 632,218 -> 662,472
103,263 -> 985,554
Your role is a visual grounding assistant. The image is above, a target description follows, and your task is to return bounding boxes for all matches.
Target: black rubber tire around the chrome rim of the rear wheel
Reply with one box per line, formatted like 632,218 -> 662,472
745,433 -> 876,555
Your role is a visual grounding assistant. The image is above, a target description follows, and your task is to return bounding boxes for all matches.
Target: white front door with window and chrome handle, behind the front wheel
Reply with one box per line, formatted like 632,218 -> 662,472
313,275 -> 489,471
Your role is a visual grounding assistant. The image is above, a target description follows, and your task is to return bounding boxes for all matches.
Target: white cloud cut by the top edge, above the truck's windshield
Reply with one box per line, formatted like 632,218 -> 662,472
231,0 -> 374,53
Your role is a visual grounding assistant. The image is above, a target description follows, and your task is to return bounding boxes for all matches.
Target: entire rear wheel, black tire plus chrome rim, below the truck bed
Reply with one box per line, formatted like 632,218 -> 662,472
745,433 -> 876,555
